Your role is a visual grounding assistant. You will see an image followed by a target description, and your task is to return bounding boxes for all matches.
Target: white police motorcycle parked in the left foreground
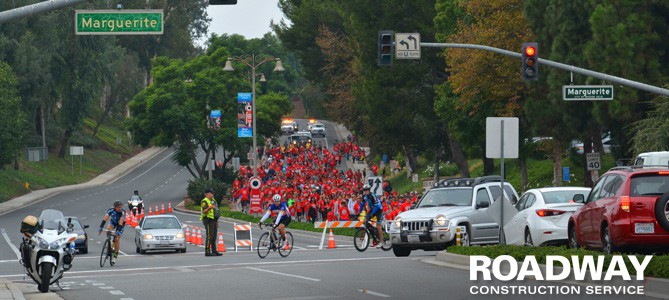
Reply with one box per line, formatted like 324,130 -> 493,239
19,209 -> 77,293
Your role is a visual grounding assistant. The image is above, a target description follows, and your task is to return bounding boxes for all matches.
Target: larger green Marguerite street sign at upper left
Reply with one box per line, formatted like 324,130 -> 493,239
74,9 -> 163,35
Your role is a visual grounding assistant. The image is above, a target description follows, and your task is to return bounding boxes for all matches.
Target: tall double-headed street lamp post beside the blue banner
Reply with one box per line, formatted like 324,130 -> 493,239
223,54 -> 285,176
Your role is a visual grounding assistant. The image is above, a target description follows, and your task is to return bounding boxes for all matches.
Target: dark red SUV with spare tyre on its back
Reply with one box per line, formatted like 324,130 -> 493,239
567,166 -> 669,253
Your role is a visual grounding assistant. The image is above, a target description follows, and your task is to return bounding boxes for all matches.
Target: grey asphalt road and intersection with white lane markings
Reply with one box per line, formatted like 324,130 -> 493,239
0,120 -> 656,300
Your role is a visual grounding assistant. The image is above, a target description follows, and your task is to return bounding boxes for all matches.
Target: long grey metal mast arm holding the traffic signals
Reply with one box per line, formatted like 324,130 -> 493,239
420,42 -> 669,96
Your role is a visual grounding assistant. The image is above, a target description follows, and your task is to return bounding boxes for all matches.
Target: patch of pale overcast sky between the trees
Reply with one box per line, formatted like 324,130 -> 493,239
207,0 -> 283,39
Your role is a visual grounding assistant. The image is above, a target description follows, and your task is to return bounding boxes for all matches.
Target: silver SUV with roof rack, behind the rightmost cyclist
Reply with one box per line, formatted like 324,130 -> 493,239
389,176 -> 518,256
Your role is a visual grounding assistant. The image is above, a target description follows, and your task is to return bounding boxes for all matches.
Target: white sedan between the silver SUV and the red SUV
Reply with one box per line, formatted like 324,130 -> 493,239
504,187 -> 590,246
